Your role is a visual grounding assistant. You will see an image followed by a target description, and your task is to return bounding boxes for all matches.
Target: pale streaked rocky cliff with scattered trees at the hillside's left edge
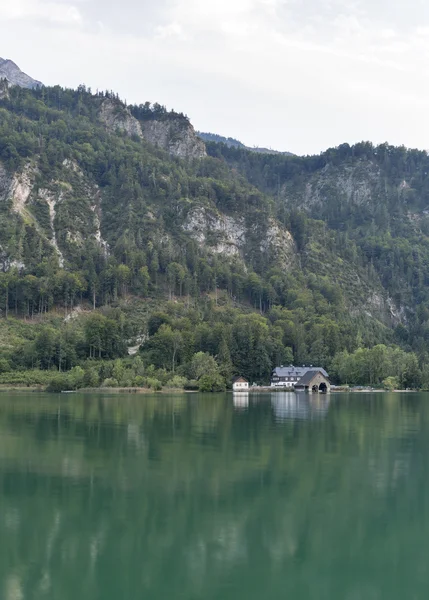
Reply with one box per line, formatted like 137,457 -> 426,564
0,159 -> 108,271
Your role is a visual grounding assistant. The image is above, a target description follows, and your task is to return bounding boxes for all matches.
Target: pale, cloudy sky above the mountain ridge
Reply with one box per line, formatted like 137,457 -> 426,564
0,0 -> 429,154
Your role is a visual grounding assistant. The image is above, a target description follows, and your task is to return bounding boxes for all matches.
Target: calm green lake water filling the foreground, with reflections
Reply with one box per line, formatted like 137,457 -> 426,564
0,393 -> 429,600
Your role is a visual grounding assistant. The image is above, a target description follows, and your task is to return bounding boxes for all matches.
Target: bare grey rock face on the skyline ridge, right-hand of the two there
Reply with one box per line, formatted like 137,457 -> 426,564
142,116 -> 207,159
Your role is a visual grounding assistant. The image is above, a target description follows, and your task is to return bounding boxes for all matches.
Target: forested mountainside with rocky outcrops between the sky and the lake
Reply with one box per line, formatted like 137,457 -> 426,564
0,86 -> 429,389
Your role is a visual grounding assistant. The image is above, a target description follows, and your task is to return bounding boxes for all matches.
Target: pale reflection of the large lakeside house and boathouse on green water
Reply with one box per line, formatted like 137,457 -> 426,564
271,392 -> 329,421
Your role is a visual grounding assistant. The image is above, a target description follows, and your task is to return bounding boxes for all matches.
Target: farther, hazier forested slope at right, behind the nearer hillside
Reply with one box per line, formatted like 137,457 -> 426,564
208,142 -> 429,332
